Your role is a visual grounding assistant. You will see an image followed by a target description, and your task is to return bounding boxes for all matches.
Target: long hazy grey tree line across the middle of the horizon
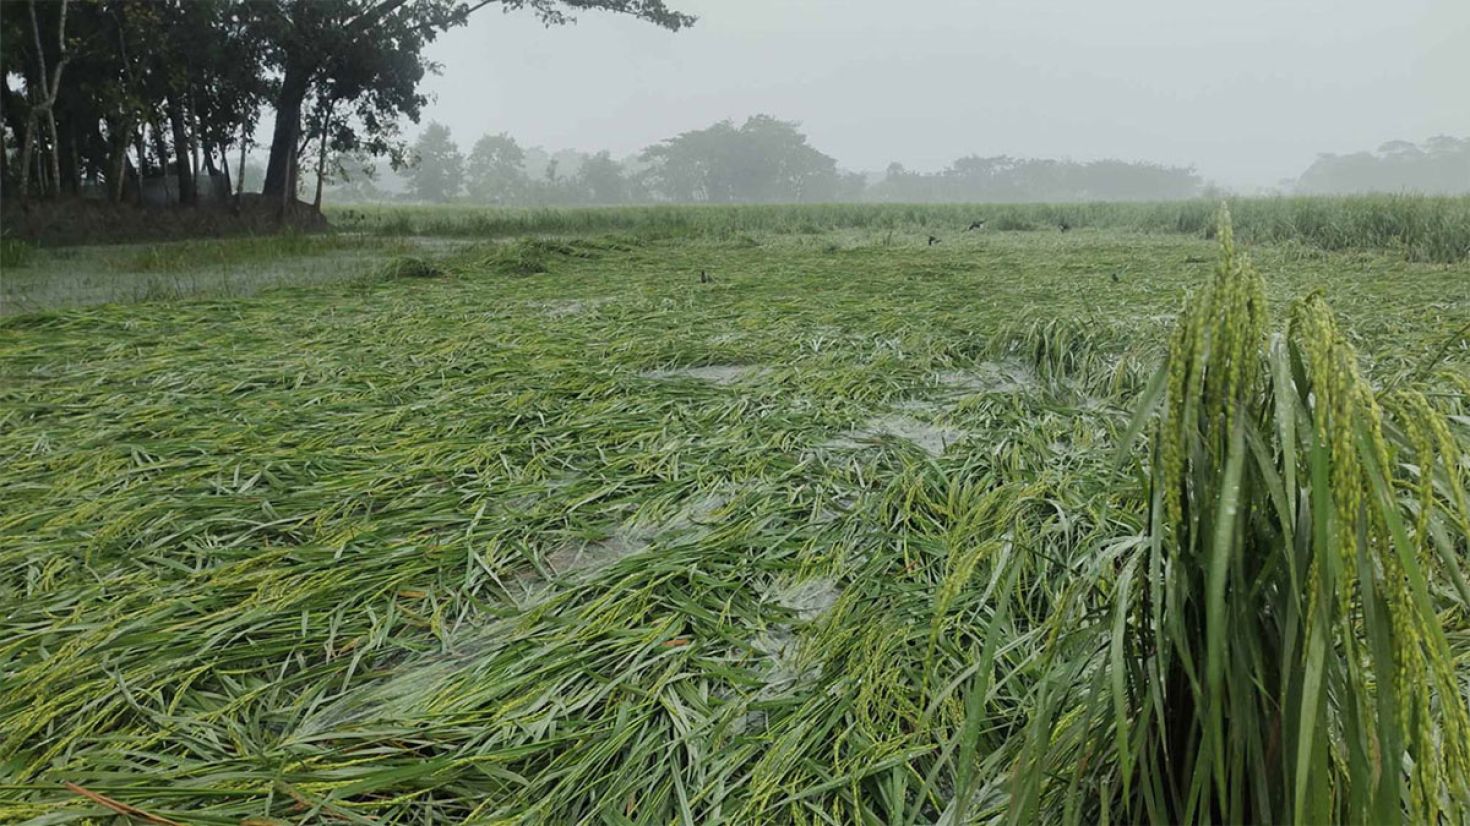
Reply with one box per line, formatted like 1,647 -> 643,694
341,115 -> 1202,206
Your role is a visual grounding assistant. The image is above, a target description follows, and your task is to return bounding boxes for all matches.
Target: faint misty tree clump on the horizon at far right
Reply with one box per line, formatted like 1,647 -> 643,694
1297,135 -> 1470,195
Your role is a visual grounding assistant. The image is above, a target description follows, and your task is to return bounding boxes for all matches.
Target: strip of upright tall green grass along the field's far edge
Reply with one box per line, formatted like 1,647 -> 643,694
331,195 -> 1470,263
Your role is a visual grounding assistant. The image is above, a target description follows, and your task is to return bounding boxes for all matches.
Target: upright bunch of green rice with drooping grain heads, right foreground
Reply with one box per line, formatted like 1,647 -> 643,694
1011,210 -> 1470,823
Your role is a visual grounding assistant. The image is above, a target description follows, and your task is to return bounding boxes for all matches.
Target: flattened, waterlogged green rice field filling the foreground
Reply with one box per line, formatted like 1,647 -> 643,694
0,200 -> 1470,826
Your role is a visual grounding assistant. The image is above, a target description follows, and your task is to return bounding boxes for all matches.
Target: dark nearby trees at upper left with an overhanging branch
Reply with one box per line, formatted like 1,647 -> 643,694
0,0 -> 692,204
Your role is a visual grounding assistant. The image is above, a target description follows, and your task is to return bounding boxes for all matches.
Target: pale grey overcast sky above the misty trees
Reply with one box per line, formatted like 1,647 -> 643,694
411,0 -> 1470,188
